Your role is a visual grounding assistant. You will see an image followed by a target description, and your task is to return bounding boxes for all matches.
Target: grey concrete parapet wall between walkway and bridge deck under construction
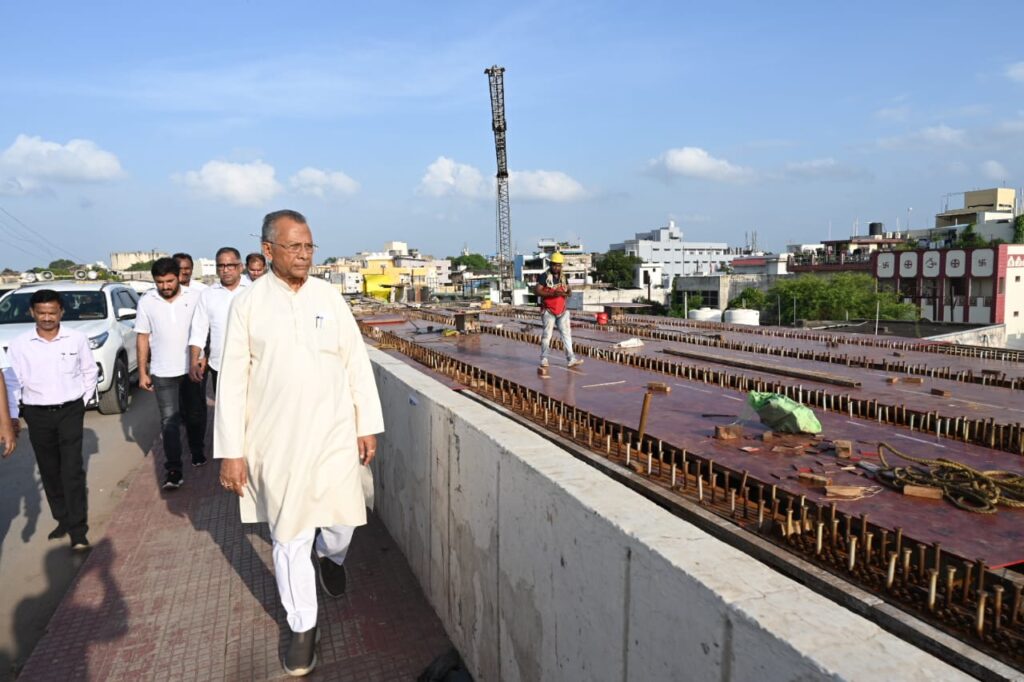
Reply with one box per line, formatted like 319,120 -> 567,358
371,349 -> 969,681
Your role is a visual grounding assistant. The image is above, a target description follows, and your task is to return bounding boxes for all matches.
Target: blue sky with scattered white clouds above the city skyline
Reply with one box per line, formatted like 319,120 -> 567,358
0,1 -> 1024,267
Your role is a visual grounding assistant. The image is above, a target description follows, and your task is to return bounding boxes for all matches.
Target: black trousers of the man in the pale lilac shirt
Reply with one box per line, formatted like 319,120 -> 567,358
22,400 -> 89,542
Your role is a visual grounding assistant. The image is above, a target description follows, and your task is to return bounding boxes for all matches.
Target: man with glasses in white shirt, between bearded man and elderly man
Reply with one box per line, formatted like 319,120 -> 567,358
188,247 -> 250,393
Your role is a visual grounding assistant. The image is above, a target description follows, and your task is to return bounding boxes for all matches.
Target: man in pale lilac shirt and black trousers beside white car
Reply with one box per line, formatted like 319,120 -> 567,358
7,289 -> 99,550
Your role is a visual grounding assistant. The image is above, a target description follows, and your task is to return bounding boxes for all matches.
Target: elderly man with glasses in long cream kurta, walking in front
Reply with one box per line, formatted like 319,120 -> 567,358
214,211 -> 384,676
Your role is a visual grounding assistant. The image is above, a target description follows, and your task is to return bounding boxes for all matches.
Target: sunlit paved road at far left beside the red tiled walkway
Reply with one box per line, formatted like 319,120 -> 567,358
0,389 -> 159,679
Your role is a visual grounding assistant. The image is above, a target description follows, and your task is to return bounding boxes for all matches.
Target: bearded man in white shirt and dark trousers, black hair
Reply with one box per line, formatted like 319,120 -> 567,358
135,258 -> 206,489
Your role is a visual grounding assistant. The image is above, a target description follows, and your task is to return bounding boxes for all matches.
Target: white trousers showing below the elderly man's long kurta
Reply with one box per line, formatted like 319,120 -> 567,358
273,525 -> 355,632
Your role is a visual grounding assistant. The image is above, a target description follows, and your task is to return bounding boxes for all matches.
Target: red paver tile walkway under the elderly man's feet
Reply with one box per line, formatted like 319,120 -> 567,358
18,446 -> 452,682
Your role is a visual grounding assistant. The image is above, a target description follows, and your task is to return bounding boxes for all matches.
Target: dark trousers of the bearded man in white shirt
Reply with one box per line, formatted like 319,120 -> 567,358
153,374 -> 206,471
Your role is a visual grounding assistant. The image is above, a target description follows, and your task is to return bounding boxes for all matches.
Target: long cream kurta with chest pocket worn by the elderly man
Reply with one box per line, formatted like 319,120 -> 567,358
214,272 -> 384,543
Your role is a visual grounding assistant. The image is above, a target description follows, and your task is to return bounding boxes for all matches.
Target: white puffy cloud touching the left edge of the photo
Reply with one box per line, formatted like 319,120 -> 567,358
0,135 -> 124,195
